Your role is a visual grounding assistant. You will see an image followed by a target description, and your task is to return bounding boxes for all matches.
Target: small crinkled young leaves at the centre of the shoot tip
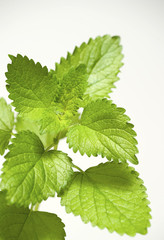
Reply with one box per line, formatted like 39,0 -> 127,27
40,65 -> 87,135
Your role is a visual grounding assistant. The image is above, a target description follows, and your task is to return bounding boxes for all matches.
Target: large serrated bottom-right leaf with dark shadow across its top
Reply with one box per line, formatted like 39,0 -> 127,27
61,162 -> 151,236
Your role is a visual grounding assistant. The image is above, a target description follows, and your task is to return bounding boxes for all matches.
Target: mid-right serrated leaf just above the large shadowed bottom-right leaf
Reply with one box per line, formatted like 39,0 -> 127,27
67,99 -> 138,164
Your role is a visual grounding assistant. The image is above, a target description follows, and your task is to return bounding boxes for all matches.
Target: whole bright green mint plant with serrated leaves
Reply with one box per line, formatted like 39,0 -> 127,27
0,35 -> 151,240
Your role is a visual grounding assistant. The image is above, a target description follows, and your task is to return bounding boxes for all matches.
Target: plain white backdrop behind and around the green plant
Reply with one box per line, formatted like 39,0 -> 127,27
0,0 -> 164,240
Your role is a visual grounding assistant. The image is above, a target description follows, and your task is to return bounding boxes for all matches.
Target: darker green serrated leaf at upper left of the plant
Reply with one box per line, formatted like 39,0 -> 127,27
6,54 -> 56,113
